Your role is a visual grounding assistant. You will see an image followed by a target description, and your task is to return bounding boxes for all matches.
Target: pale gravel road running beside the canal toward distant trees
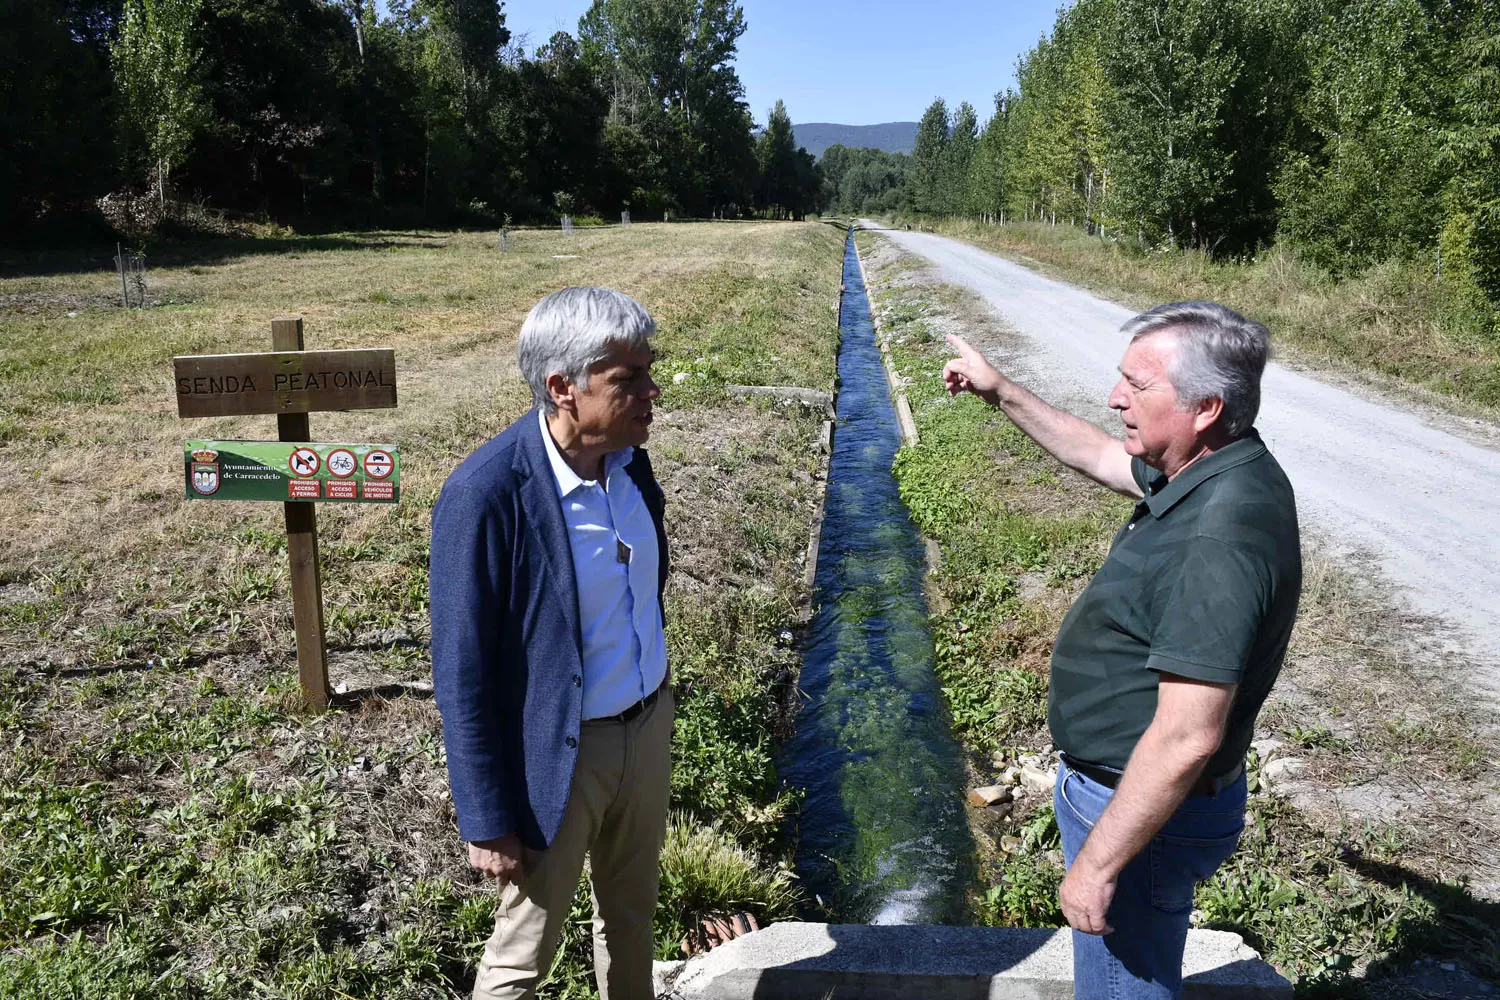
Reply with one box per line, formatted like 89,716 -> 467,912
861,222 -> 1500,700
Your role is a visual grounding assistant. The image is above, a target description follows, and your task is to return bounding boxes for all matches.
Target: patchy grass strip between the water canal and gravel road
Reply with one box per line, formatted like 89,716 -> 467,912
857,234 -> 1500,996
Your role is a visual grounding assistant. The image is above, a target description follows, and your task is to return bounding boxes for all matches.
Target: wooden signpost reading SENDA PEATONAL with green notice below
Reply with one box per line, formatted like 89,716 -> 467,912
173,316 -> 399,709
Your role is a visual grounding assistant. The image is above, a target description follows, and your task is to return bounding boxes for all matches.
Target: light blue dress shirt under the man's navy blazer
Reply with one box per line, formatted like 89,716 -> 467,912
537,409 -> 666,718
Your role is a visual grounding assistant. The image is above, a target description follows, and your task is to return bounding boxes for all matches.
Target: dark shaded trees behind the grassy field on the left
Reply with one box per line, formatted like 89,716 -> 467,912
0,0 -> 822,239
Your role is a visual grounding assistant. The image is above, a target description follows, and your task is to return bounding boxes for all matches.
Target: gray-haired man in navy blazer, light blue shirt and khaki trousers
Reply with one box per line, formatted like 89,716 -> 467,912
431,288 -> 672,1000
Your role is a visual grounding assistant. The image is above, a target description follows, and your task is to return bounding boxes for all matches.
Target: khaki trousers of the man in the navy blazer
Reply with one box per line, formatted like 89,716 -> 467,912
474,688 -> 674,1000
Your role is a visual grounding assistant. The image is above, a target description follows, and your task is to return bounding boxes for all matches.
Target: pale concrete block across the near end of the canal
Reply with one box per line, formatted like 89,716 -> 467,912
662,922 -> 1292,1000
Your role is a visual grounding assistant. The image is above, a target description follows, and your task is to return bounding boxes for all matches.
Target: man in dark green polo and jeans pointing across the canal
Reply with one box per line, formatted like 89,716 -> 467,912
944,301 -> 1302,999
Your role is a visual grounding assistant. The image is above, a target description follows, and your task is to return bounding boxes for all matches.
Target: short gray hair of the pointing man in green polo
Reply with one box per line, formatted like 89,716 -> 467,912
1121,301 -> 1271,438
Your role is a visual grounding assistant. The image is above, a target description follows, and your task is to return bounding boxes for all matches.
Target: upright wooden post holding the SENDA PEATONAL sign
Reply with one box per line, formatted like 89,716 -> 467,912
272,316 -> 329,711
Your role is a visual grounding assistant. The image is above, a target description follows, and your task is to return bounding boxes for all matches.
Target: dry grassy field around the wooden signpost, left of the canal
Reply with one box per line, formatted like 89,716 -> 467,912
0,223 -> 842,999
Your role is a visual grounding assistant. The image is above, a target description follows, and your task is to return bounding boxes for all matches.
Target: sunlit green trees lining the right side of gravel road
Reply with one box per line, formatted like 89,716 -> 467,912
825,0 -> 1500,310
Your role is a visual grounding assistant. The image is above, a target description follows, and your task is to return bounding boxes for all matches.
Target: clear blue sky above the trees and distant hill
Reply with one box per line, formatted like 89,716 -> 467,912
381,0 -> 1061,124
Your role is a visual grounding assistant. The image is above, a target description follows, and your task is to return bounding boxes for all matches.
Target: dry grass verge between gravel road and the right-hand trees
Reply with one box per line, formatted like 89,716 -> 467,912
900,220 -> 1500,420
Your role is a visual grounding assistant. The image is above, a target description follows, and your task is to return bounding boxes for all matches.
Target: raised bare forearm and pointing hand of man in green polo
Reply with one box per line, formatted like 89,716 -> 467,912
942,333 -> 1142,498
